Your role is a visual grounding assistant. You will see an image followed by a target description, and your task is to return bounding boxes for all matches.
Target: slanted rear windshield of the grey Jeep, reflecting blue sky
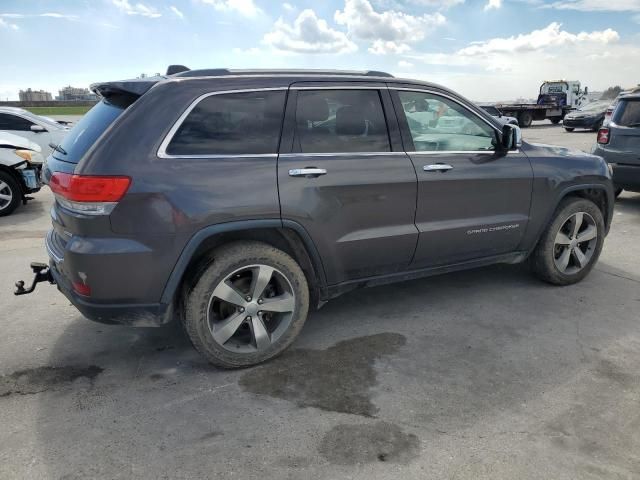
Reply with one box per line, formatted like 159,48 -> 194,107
52,100 -> 125,163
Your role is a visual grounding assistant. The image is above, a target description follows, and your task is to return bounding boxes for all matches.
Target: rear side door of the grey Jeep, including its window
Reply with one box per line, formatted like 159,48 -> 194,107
278,82 -> 417,284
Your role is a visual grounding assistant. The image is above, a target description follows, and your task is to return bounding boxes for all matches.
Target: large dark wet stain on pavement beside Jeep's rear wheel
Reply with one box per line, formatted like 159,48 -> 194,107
240,333 -> 406,417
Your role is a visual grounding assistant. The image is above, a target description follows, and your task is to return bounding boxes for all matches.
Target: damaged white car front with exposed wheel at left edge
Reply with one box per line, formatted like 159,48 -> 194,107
0,132 -> 44,217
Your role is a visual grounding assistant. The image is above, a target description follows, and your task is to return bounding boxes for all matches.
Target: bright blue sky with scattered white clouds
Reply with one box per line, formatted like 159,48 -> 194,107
0,0 -> 640,101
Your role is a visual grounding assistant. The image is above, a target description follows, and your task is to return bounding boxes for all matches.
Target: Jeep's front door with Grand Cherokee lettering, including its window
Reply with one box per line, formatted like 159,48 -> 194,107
390,87 -> 533,268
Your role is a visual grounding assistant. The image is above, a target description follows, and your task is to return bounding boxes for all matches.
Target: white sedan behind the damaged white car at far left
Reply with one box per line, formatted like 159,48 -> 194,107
0,107 -> 69,157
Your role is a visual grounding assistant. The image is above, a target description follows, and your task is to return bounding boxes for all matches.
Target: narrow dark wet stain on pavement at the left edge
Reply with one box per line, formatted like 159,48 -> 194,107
0,365 -> 103,397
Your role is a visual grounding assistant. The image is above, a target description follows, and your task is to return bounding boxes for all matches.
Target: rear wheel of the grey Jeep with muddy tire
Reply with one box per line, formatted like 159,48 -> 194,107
183,242 -> 309,368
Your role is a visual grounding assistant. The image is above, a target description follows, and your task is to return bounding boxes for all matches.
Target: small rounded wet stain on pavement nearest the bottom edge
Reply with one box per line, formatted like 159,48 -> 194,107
318,422 -> 420,465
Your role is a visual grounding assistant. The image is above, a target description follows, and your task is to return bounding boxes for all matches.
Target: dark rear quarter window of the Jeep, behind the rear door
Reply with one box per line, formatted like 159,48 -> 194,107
167,91 -> 285,155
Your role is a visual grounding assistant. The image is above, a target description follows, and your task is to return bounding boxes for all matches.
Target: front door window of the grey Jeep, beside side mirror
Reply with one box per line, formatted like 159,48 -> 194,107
398,91 -> 496,152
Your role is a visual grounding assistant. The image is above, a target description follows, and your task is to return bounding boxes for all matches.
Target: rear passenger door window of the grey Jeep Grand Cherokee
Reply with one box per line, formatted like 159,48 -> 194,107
295,90 -> 391,153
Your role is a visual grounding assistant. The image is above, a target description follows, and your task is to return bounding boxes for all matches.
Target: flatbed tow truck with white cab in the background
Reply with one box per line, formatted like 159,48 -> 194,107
496,80 -> 589,128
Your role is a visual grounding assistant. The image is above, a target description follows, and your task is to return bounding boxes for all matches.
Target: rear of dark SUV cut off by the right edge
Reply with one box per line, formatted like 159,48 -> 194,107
593,93 -> 640,194
